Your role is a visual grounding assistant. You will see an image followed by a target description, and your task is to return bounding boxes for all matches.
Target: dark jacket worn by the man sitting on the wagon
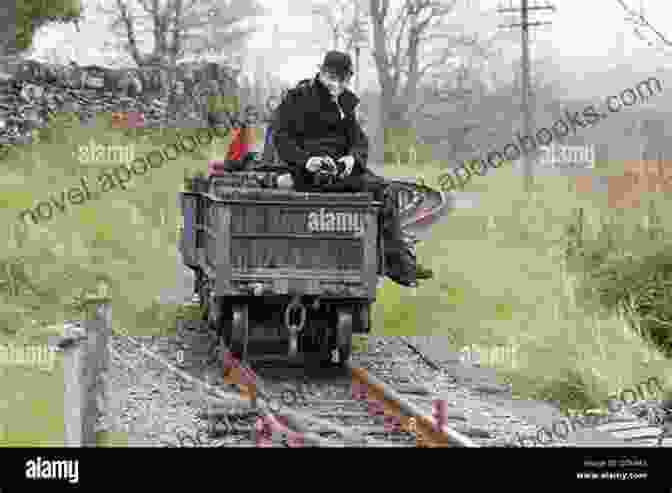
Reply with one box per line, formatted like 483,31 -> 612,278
273,76 -> 369,189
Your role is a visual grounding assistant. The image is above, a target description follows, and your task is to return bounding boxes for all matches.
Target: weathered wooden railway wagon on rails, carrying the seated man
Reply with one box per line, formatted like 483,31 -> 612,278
181,172 -> 384,366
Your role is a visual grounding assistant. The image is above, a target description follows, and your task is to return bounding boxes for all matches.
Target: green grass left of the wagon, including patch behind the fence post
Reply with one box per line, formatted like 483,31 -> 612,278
0,115 -> 228,446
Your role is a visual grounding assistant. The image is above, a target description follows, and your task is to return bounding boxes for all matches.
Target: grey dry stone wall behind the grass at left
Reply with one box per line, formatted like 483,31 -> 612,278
0,60 -> 238,144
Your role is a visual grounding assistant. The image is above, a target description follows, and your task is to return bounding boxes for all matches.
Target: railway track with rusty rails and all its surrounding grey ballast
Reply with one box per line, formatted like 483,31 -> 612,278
67,312 -> 672,448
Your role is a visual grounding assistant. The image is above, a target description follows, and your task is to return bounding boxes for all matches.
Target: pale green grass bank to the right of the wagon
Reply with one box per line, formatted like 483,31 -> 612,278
375,158 -> 672,410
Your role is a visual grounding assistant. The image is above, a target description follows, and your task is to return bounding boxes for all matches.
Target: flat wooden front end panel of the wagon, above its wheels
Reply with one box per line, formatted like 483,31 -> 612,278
206,194 -> 378,299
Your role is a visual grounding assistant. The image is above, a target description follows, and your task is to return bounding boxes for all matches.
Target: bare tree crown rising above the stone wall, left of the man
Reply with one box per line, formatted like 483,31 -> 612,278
98,0 -> 264,66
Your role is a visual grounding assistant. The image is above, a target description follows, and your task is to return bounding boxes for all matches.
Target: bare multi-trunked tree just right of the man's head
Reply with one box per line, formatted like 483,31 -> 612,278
369,0 -> 490,165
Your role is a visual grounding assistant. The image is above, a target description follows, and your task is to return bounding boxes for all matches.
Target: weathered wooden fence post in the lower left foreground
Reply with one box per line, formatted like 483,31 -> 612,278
55,280 -> 112,447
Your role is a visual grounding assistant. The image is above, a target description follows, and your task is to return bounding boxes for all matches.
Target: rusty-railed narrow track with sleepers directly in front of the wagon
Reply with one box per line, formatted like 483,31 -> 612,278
110,324 -> 478,447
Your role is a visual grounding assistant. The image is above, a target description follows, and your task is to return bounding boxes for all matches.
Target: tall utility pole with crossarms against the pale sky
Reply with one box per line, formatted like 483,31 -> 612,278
497,0 -> 555,192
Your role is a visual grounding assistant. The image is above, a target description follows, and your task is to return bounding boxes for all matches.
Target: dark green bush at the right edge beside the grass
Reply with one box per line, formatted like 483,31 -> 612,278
566,198 -> 672,356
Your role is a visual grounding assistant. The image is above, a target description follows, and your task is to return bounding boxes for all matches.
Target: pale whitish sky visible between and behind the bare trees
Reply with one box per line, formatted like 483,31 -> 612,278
26,0 -> 672,97
